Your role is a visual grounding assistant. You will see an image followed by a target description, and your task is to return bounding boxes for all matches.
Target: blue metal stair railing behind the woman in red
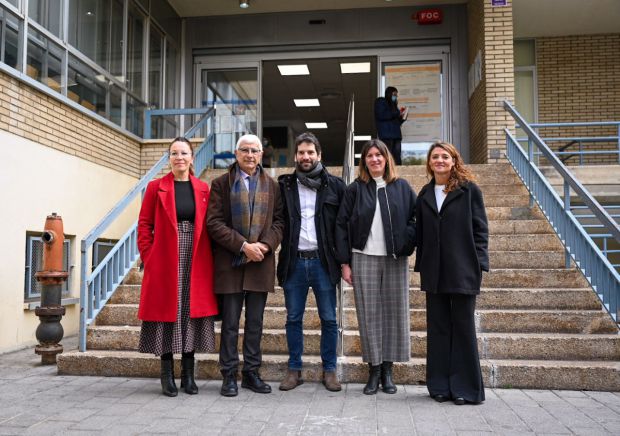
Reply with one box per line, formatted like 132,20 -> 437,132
79,108 -> 215,351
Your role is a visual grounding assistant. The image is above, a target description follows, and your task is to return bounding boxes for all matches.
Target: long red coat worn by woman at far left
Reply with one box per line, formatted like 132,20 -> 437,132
138,173 -> 217,322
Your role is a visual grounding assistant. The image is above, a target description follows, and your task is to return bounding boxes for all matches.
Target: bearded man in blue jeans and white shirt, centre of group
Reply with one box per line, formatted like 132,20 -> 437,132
277,133 -> 345,392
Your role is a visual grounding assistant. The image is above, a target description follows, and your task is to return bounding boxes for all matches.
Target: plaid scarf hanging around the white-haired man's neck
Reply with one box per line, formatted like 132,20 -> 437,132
230,165 -> 269,266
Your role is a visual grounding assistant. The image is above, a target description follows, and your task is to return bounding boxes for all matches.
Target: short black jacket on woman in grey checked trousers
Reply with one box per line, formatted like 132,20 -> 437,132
336,178 -> 416,264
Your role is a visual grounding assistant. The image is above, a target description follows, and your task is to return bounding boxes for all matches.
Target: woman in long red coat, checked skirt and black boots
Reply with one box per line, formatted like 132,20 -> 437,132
138,138 -> 217,397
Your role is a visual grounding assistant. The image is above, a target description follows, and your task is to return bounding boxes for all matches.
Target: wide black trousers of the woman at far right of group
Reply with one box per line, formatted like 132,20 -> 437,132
426,292 -> 484,403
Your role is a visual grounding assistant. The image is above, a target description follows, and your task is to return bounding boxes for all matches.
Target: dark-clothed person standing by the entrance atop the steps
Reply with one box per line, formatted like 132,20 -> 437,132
375,86 -> 407,165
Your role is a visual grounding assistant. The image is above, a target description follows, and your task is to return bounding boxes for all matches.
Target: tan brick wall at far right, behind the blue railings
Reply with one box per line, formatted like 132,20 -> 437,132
536,34 -> 620,164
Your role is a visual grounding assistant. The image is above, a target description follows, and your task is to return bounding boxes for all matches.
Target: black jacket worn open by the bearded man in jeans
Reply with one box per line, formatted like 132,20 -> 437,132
277,169 -> 345,285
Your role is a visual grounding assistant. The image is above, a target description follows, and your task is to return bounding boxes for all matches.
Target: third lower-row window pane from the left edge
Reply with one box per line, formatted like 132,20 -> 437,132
67,54 -> 108,116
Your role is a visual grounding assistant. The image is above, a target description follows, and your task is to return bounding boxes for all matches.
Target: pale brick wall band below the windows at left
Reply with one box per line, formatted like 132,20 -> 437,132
0,72 -> 140,177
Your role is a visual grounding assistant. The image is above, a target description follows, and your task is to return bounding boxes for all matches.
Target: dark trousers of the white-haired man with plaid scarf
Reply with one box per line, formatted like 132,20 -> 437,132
218,292 -> 267,371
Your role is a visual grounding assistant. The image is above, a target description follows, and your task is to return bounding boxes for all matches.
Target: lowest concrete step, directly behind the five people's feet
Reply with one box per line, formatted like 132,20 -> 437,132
58,350 -> 620,391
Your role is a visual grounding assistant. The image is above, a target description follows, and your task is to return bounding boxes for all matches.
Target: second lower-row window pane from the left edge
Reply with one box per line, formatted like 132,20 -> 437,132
26,27 -> 64,92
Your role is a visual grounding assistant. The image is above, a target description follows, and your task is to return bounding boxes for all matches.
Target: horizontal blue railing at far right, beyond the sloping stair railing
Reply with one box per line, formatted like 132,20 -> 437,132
517,121 -> 620,165
